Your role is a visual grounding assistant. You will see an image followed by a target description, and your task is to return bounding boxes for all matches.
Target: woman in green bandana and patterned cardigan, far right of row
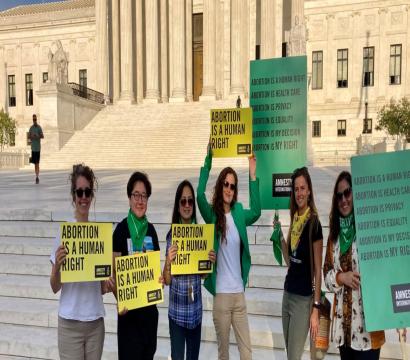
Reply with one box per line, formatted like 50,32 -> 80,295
323,171 -> 385,360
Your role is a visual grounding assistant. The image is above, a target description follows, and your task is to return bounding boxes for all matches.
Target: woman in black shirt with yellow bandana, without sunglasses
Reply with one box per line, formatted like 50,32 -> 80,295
282,167 -> 323,360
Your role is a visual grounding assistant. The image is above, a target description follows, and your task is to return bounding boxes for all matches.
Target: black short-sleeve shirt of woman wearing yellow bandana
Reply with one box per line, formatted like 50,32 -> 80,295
285,220 -> 323,296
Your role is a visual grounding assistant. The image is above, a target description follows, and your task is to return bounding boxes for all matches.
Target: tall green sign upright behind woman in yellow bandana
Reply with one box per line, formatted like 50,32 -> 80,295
250,56 -> 307,209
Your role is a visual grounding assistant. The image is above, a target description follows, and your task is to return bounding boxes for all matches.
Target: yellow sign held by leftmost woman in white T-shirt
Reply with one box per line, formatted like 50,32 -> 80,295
60,222 -> 112,283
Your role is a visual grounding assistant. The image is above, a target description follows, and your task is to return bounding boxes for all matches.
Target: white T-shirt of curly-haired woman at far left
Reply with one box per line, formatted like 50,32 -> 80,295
50,232 -> 105,321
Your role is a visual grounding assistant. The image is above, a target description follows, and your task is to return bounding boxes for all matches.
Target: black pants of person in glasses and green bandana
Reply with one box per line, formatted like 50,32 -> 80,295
117,305 -> 158,360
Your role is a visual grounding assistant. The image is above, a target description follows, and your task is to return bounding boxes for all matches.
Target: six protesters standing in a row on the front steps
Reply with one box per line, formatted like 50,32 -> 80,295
50,146 -> 406,360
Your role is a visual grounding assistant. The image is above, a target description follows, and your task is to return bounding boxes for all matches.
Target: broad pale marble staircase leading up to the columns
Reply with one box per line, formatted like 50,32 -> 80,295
41,100 -> 247,169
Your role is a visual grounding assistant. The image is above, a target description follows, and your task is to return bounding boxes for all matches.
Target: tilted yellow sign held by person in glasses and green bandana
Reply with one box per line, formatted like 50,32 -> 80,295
115,251 -> 164,312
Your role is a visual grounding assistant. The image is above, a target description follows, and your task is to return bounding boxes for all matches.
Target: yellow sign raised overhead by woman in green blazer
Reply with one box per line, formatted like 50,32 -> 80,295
210,108 -> 252,157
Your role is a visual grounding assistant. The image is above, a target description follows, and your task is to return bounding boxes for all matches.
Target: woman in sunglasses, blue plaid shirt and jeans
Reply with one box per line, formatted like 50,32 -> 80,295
163,180 -> 216,360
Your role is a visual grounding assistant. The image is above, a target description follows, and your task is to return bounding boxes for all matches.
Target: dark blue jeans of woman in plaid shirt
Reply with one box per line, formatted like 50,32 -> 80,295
168,317 -> 202,360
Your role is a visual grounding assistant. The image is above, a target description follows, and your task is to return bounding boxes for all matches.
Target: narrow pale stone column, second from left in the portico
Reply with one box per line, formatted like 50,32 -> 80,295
111,0 -> 121,102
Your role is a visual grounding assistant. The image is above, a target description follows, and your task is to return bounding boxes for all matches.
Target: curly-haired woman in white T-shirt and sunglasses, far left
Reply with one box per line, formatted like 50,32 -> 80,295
50,164 -> 105,360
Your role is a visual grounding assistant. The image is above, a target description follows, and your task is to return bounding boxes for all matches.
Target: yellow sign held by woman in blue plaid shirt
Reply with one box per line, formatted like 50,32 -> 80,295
171,224 -> 215,275
